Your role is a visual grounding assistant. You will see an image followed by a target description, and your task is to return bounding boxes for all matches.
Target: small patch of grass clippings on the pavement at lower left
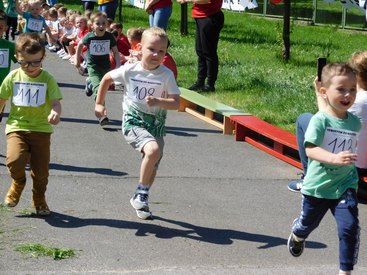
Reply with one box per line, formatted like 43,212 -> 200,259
16,243 -> 76,260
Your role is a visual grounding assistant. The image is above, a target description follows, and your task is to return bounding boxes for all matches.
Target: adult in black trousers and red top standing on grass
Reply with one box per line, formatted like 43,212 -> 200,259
178,0 -> 224,92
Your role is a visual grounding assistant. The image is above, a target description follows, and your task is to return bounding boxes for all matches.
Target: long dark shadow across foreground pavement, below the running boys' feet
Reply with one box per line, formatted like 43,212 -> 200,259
17,212 -> 326,249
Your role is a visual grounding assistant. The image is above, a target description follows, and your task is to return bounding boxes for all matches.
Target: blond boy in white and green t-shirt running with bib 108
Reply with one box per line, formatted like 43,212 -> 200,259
95,27 -> 180,219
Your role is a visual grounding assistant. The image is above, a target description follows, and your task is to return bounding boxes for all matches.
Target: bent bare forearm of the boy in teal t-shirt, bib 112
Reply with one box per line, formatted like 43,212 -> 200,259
306,144 -> 357,165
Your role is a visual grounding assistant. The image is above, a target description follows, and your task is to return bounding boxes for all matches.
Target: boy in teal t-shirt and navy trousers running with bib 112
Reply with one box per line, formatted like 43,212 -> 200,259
287,63 -> 361,275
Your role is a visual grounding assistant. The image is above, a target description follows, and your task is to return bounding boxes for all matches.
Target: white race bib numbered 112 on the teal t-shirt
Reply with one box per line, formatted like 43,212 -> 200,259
321,127 -> 358,154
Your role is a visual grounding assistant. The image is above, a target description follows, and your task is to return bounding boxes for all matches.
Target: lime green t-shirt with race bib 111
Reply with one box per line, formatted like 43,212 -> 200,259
0,68 -> 62,134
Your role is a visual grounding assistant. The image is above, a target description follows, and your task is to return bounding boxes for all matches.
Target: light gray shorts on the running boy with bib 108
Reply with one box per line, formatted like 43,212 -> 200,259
124,127 -> 164,168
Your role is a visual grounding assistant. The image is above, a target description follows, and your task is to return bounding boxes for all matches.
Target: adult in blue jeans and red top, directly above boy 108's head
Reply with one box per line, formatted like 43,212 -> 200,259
145,0 -> 172,30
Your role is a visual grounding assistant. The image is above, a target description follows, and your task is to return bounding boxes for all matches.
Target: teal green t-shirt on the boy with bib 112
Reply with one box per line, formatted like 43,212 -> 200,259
302,112 -> 361,199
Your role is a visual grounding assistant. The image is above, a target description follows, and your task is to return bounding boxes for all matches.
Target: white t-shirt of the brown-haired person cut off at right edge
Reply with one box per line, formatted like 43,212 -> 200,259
349,91 -> 367,169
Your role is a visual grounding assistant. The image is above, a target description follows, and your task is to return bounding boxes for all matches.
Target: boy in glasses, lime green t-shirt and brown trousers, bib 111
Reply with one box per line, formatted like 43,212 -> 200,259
0,32 -> 62,216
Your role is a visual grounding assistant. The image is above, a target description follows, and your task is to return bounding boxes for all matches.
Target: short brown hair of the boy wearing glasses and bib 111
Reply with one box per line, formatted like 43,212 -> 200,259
15,32 -> 45,54
